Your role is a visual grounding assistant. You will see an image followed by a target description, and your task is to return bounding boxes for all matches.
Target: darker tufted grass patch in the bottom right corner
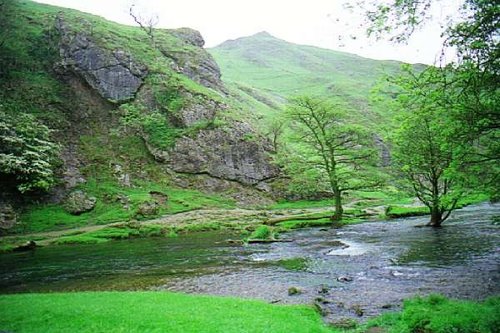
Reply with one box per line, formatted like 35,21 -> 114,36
367,295 -> 500,333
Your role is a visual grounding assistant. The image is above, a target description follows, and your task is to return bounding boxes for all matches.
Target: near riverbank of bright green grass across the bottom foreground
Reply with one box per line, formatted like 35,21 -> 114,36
0,292 -> 500,333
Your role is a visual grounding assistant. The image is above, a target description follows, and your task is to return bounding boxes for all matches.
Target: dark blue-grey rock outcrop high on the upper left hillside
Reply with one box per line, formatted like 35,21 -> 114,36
56,14 -> 147,102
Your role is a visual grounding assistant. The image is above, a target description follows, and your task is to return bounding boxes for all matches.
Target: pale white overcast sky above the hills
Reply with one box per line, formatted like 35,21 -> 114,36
37,0 -> 460,64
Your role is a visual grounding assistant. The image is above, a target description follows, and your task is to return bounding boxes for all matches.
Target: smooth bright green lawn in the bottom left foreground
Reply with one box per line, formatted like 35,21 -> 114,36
0,292 -> 331,333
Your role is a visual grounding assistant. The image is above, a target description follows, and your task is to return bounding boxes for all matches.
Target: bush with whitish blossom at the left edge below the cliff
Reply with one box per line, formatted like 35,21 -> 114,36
0,109 -> 59,193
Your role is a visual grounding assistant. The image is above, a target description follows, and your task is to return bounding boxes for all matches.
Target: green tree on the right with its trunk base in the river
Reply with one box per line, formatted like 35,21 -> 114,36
393,67 -> 474,227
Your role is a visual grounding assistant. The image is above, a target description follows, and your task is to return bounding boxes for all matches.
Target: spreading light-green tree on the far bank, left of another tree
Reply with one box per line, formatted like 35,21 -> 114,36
285,96 -> 380,220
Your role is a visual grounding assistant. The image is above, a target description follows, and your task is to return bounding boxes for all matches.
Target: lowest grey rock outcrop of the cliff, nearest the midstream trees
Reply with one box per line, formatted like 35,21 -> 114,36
164,123 -> 279,185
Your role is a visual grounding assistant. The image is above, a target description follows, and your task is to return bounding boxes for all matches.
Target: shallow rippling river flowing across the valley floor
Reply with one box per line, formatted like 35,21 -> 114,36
0,204 -> 500,320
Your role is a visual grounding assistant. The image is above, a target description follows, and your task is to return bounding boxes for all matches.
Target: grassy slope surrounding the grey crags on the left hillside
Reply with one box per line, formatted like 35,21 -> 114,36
0,0 -> 248,231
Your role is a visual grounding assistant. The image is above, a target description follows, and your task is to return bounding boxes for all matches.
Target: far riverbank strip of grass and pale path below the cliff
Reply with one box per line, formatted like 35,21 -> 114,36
0,192 -> 487,253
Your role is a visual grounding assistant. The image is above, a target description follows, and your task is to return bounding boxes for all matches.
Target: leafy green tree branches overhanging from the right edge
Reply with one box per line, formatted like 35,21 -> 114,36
363,0 -> 500,198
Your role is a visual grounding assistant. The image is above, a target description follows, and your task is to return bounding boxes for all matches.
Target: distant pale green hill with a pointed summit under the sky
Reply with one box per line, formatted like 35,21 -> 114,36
209,32 -> 416,125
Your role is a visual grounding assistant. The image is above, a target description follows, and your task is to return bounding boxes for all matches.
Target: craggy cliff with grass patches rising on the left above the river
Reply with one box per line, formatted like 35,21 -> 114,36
0,1 -> 279,226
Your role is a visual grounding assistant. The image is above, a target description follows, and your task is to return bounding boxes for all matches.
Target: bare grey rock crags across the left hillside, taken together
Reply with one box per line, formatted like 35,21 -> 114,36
55,14 -> 279,195
